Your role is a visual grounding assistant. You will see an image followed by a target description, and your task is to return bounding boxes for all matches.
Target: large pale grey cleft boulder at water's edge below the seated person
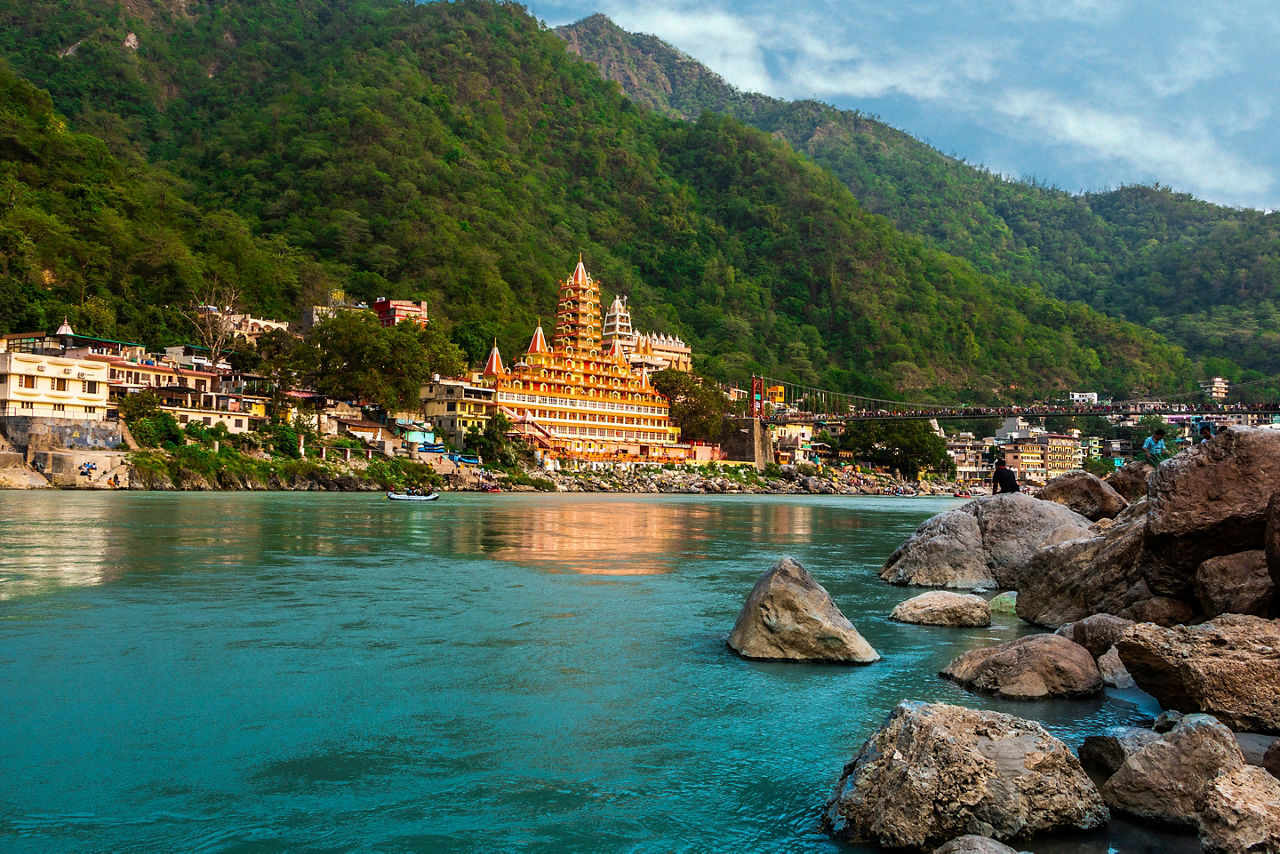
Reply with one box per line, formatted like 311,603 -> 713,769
881,493 -> 1091,588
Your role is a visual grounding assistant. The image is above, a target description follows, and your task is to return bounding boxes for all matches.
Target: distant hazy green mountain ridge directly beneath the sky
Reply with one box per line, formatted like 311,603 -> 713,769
557,15 -> 1280,374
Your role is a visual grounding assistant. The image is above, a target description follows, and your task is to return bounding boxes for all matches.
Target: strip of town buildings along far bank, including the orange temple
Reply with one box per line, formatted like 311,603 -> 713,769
0,259 -> 1276,489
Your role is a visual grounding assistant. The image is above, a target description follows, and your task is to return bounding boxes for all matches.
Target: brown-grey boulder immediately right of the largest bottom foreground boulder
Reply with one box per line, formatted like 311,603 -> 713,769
1102,714 -> 1244,827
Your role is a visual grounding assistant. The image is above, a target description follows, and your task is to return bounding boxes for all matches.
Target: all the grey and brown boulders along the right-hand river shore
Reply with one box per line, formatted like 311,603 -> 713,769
730,428 -> 1280,854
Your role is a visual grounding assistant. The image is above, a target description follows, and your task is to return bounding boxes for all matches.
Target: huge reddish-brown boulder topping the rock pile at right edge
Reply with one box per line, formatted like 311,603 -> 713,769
1142,426 -> 1280,600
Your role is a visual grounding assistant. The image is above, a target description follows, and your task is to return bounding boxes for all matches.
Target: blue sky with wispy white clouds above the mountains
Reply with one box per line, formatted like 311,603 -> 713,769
526,0 -> 1280,210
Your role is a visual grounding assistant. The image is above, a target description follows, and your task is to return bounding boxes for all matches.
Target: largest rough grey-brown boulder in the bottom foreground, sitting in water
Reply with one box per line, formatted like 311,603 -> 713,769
823,700 -> 1110,849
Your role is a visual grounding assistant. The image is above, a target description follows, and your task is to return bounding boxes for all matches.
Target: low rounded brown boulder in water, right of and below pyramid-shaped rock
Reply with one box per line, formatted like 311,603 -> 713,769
941,635 -> 1102,700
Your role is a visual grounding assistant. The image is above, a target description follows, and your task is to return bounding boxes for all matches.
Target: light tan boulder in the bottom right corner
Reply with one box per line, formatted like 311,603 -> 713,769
1199,766 -> 1280,854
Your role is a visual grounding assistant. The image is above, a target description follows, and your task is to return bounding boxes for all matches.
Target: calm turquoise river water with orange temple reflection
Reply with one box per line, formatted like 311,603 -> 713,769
0,492 -> 1197,854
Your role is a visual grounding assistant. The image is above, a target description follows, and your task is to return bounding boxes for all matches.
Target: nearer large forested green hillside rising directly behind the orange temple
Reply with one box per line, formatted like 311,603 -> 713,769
0,0 -> 1194,401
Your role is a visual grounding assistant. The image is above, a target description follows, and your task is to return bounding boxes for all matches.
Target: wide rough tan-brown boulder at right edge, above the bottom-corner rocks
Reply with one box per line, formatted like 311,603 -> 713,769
1116,615 -> 1280,732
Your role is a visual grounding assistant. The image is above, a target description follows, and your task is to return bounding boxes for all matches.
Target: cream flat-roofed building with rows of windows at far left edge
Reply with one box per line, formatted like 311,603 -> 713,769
0,351 -> 109,421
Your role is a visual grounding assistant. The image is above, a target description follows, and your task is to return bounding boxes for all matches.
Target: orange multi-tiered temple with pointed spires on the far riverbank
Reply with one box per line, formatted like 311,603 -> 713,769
481,259 -> 687,461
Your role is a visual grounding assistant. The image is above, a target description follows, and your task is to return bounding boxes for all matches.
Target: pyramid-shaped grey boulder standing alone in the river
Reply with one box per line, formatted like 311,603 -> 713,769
728,557 -> 879,665
